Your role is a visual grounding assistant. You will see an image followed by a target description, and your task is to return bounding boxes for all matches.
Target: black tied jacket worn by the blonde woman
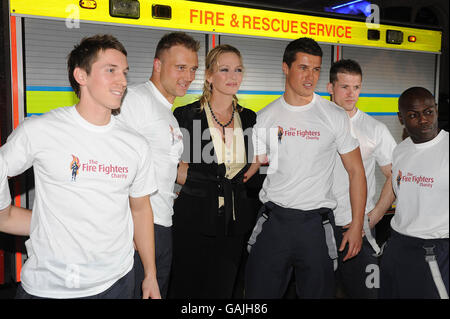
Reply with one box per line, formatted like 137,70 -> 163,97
173,101 -> 262,236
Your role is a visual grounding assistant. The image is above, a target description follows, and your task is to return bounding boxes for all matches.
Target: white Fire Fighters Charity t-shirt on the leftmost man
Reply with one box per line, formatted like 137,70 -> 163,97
0,106 -> 157,298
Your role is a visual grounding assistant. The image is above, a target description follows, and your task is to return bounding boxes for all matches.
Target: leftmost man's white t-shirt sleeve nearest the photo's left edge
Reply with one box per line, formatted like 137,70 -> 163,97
0,119 -> 33,177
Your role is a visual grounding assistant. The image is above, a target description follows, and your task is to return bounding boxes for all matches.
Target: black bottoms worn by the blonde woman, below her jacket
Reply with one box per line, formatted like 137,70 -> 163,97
169,227 -> 244,299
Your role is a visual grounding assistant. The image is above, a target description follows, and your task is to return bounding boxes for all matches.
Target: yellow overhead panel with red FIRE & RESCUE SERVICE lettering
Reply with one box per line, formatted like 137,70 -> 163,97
10,0 -> 442,53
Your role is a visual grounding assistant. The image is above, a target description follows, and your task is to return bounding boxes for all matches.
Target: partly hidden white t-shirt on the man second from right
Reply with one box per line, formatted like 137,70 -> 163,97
333,110 -> 397,226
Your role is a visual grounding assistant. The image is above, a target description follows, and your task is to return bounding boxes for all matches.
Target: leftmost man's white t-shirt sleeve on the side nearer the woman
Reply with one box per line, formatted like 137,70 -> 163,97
130,143 -> 158,197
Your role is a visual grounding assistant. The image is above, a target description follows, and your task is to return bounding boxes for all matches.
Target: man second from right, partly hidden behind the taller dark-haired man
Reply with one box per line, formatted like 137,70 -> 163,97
327,60 -> 396,299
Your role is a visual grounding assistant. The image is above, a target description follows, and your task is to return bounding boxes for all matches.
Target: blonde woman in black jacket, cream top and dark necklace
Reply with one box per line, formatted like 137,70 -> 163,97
169,45 -> 261,298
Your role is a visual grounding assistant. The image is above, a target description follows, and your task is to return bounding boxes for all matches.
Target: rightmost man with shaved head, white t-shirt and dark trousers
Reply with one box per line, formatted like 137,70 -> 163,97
380,87 -> 449,299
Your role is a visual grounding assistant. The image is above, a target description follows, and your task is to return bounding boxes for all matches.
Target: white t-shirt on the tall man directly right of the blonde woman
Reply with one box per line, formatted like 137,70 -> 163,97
253,94 -> 358,210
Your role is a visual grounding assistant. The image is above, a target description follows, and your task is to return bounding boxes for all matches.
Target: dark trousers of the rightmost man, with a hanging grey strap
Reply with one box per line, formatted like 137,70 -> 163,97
380,229 -> 449,299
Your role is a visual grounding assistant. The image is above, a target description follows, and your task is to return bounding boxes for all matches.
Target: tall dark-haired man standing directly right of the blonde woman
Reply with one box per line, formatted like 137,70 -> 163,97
245,38 -> 366,298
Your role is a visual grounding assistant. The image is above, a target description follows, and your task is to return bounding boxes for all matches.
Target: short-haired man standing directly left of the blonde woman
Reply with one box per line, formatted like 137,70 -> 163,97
120,32 -> 199,298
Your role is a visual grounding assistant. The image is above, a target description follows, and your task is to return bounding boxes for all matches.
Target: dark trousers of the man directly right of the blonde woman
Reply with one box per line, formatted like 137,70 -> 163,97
245,206 -> 335,299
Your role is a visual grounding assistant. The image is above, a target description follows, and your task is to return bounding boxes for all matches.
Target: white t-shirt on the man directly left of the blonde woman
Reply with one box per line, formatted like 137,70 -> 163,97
119,81 -> 183,227
